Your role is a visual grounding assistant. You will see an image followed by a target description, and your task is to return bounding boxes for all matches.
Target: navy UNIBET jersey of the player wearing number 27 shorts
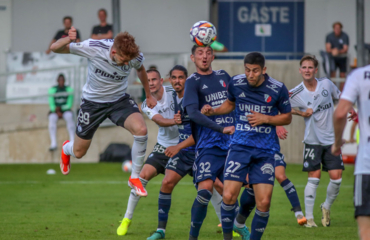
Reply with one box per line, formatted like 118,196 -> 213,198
228,74 -> 291,152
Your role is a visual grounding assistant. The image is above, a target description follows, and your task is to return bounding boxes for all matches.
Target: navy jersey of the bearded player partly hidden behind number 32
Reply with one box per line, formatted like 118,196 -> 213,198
173,92 -> 195,152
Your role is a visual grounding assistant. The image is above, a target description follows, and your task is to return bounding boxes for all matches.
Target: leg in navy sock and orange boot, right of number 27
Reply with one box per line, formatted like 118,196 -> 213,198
275,164 -> 307,225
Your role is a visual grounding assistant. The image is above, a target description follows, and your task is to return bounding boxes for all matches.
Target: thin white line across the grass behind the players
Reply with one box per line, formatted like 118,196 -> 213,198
0,181 -> 353,188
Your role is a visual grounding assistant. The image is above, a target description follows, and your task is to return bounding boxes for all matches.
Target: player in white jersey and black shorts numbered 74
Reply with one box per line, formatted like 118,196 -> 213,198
290,56 -> 356,227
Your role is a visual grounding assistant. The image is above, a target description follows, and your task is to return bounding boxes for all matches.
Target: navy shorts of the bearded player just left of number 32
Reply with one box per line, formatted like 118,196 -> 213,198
166,150 -> 195,177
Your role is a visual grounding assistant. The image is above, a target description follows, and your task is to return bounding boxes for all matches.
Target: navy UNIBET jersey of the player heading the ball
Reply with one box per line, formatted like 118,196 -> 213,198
183,70 -> 234,150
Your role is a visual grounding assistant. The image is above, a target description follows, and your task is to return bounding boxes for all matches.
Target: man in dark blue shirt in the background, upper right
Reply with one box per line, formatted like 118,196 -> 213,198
325,22 -> 349,78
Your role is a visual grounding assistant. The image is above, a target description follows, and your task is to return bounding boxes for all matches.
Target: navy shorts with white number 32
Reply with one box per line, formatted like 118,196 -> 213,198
193,147 -> 227,183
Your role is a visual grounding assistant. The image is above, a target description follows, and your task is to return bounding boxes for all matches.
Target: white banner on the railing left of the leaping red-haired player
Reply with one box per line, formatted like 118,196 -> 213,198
6,52 -> 86,103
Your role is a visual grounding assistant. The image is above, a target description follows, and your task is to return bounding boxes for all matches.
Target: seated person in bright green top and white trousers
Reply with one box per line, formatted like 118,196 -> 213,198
48,74 -> 75,151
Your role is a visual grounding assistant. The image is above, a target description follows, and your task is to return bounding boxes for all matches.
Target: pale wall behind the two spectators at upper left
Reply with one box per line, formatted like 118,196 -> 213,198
11,0 -> 112,52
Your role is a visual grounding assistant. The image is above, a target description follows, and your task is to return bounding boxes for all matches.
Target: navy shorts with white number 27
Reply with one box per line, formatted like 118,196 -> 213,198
224,144 -> 275,185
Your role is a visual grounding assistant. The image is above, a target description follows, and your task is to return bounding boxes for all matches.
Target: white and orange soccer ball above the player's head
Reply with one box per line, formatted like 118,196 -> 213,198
190,21 -> 217,47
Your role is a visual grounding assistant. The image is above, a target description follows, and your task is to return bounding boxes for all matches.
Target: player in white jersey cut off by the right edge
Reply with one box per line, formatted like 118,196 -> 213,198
332,65 -> 370,240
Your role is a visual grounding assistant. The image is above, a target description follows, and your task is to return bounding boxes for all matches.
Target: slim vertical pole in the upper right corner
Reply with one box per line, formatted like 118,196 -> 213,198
356,0 -> 366,67
